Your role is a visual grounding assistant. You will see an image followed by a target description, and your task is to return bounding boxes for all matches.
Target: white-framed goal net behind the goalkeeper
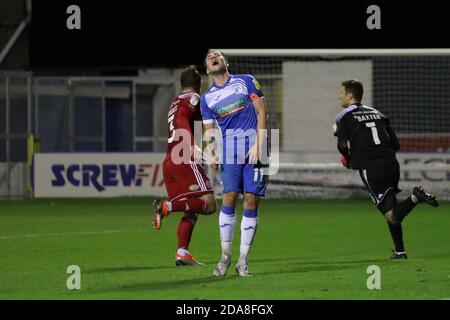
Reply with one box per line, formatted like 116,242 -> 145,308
214,49 -> 450,200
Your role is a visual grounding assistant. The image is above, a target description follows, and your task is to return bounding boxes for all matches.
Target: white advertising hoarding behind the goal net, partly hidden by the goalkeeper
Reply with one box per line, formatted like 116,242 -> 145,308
267,151 -> 450,201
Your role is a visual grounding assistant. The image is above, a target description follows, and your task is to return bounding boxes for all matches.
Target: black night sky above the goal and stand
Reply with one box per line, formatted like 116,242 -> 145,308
30,0 -> 450,69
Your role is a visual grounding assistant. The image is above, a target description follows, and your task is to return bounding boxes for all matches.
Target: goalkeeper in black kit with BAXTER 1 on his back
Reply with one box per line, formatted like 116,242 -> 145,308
333,80 -> 439,259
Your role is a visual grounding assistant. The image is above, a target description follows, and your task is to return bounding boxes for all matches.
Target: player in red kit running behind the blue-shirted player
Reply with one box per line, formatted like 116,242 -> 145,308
153,66 -> 216,266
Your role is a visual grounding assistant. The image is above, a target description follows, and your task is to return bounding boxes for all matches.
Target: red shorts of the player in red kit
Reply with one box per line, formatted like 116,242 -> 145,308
163,158 -> 213,201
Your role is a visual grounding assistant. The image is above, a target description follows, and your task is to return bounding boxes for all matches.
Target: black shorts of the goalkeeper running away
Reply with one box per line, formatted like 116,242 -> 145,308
359,161 -> 401,214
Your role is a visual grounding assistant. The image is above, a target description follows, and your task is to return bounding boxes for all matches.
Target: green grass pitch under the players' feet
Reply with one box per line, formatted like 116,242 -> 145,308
0,198 -> 450,300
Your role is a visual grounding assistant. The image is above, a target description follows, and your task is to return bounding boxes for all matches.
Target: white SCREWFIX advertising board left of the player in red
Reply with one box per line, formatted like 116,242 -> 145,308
34,153 -> 166,198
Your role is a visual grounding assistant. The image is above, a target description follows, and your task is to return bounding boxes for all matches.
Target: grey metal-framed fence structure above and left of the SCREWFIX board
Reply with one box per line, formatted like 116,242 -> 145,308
0,69 -> 188,199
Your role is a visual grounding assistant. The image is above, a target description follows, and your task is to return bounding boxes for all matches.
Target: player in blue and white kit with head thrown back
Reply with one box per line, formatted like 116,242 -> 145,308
201,50 -> 268,276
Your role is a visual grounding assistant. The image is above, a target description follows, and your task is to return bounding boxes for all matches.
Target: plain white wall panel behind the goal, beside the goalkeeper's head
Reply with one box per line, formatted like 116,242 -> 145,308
282,60 -> 372,152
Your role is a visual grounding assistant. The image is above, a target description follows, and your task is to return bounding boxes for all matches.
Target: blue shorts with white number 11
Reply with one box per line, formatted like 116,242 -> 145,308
220,163 -> 268,197
